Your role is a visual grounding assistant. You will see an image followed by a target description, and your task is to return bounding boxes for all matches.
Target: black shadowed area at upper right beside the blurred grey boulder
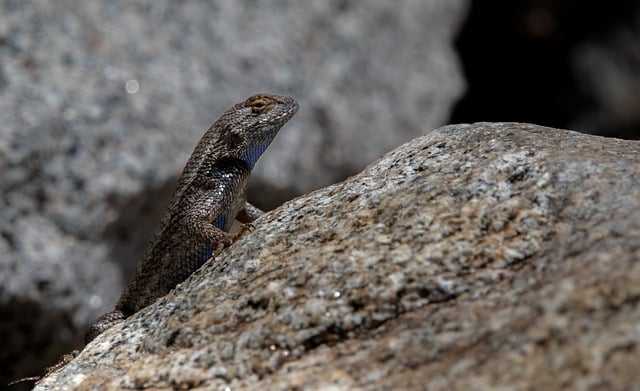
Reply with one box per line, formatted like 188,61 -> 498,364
450,0 -> 640,139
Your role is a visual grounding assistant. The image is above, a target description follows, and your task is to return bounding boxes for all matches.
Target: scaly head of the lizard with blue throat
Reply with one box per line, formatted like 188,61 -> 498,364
218,94 -> 298,167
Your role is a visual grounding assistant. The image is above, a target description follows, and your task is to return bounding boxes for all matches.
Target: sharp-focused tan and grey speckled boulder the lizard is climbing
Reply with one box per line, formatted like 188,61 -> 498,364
41,123 -> 640,390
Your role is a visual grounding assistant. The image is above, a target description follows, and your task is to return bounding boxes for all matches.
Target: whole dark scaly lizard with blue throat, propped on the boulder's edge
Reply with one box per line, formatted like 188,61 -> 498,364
85,94 -> 298,344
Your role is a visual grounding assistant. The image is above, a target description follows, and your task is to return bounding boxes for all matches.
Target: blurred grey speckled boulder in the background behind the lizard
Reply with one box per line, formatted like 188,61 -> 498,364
0,0 -> 467,383
